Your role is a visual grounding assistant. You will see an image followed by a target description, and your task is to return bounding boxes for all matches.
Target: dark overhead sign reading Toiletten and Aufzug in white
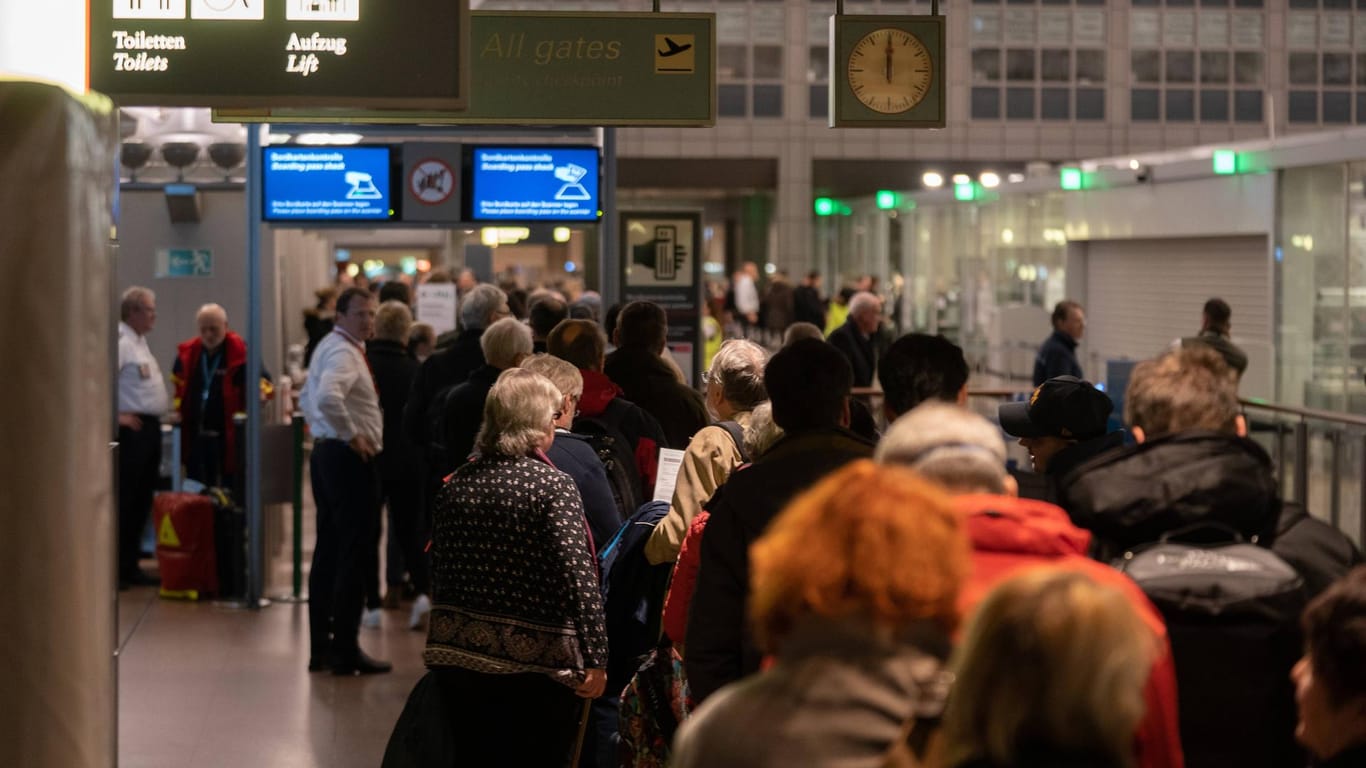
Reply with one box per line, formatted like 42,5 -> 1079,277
87,0 -> 470,109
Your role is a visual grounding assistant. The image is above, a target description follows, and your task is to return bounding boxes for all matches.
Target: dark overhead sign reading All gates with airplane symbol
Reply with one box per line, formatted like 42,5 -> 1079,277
213,10 -> 716,126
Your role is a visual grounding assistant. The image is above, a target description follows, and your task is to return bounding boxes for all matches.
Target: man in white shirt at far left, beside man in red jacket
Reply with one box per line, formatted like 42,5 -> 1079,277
119,286 -> 171,589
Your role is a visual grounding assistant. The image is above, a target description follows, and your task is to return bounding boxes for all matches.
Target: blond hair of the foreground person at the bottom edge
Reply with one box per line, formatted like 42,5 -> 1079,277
944,567 -> 1157,768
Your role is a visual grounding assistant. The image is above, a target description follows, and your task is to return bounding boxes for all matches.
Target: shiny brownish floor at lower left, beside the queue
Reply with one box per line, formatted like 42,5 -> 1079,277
119,470 -> 425,768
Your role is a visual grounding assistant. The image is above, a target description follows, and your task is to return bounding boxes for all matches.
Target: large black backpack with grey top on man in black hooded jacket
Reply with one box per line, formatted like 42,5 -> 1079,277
1116,523 -> 1306,768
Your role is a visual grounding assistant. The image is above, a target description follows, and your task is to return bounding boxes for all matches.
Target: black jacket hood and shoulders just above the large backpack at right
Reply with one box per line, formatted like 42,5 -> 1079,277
1059,430 -> 1281,560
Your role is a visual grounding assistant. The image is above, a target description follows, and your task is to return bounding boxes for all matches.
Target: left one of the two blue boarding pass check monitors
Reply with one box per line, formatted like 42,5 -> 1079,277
262,146 -> 393,221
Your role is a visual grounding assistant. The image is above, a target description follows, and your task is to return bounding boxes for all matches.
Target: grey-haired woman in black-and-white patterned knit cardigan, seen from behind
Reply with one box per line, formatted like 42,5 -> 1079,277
423,368 -> 607,765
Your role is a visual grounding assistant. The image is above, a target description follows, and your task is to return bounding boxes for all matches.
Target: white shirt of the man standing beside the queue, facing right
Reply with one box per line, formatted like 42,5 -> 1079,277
299,328 -> 384,451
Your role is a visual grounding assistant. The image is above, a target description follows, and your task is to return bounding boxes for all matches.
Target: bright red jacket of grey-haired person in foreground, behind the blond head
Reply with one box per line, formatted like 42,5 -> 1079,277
956,495 -> 1186,768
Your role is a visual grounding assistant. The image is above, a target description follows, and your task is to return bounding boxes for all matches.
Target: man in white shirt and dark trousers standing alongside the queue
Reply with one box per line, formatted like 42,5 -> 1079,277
299,288 -> 392,675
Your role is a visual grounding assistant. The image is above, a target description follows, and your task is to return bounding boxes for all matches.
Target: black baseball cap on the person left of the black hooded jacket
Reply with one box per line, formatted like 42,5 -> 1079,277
997,376 -> 1115,440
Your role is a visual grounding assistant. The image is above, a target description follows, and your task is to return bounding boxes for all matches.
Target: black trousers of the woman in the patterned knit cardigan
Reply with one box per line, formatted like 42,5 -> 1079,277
432,667 -> 583,768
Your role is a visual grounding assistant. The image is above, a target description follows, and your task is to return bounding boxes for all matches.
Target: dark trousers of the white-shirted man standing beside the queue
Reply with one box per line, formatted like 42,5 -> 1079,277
309,440 -> 380,659
